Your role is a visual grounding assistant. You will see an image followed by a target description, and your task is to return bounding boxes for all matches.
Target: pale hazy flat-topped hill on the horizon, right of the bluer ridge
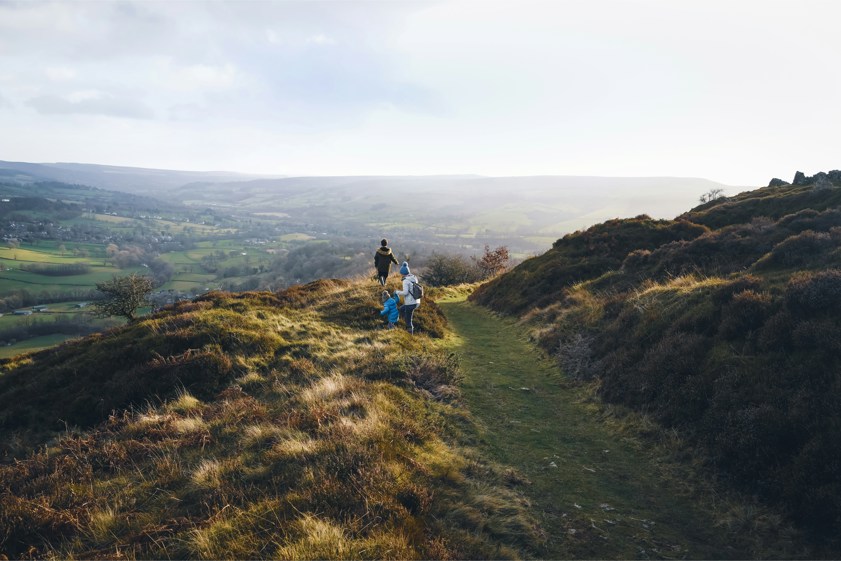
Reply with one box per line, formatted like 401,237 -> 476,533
173,175 -> 726,235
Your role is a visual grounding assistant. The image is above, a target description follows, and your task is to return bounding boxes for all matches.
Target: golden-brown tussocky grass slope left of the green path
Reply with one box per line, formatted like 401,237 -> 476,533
0,281 -> 541,559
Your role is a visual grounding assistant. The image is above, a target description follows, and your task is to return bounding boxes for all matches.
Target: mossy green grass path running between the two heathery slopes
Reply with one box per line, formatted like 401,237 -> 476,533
439,299 -> 749,559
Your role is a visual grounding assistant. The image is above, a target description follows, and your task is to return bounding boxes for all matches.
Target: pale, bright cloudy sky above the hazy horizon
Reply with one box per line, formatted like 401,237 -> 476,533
0,0 -> 841,186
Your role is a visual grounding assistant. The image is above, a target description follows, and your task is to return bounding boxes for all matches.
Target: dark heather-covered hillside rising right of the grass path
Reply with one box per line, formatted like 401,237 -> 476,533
474,178 -> 841,552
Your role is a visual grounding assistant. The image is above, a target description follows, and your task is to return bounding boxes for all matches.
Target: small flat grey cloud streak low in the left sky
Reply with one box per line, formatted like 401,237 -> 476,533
29,91 -> 154,119
